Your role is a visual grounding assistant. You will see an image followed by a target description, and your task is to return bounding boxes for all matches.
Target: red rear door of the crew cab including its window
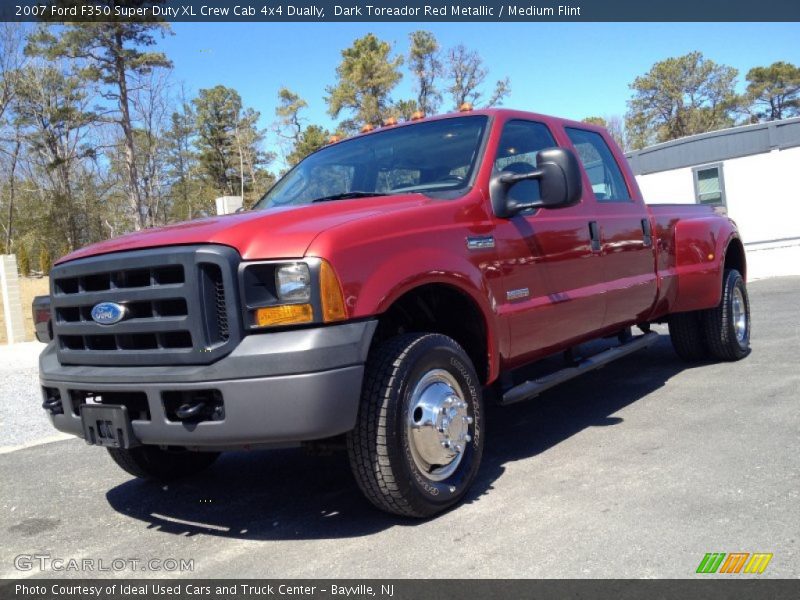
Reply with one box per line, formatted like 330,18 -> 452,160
565,127 -> 658,328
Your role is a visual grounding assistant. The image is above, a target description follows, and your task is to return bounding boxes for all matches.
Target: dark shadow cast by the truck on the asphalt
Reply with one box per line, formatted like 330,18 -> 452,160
106,336 -> 687,540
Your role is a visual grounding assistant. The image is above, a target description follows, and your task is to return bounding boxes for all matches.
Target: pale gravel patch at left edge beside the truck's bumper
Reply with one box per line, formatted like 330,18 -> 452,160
0,342 -> 68,453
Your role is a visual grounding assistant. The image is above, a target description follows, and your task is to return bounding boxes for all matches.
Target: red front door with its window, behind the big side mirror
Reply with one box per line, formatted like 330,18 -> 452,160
494,120 -> 605,366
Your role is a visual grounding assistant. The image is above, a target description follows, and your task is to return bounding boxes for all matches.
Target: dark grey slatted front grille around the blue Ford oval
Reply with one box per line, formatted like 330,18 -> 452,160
51,246 -> 239,365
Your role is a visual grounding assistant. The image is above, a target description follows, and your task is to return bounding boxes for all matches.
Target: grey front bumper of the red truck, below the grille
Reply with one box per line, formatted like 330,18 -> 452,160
39,321 -> 377,448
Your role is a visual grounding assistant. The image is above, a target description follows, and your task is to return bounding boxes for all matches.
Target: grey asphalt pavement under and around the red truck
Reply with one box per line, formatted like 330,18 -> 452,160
0,277 -> 800,578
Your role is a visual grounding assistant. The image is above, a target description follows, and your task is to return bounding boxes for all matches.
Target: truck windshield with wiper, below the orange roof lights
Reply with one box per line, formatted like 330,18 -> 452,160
255,115 -> 487,209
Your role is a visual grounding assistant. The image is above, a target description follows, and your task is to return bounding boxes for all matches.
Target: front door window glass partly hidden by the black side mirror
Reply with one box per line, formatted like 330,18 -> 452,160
494,121 -> 557,202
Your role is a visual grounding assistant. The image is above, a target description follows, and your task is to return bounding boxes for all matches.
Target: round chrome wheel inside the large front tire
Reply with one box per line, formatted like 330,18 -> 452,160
406,369 -> 472,481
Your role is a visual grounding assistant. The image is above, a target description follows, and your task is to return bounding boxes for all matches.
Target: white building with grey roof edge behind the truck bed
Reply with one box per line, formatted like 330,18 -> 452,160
628,118 -> 800,246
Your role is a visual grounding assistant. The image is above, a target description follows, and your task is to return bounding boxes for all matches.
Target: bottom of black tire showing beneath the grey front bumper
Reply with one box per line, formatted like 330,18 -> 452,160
107,446 -> 220,481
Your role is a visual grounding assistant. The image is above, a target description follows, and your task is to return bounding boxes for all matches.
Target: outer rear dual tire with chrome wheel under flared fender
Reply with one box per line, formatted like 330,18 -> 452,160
703,269 -> 750,361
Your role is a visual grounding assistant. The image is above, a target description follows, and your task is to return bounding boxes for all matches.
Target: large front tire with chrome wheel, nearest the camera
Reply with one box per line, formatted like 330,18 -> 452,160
347,333 -> 484,518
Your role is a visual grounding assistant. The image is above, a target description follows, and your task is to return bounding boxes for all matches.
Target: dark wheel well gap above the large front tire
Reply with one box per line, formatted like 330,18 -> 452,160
372,284 -> 489,382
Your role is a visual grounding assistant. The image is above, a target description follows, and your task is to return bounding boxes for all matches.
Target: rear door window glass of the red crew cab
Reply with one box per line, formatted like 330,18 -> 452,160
567,127 -> 631,202
